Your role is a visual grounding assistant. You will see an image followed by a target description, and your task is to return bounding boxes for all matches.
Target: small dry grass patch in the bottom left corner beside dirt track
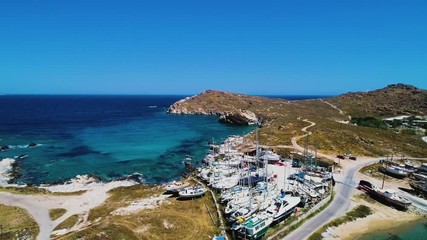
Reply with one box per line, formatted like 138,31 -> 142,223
0,204 -> 40,239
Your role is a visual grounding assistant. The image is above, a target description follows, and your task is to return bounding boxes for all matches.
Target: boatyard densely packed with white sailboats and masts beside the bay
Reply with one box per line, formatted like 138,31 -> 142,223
169,136 -> 333,239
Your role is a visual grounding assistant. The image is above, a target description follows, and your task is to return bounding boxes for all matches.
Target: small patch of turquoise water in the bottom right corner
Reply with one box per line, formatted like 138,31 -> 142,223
357,220 -> 427,240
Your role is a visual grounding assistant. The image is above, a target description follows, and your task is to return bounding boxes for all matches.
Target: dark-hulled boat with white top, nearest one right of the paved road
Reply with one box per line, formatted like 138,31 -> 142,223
358,180 -> 412,210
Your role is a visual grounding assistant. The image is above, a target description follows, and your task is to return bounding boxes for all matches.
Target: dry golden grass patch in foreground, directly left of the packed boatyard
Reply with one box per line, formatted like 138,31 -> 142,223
59,185 -> 219,239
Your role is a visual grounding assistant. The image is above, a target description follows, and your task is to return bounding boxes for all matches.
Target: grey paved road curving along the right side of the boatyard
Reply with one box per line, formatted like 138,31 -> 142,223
284,159 -> 378,240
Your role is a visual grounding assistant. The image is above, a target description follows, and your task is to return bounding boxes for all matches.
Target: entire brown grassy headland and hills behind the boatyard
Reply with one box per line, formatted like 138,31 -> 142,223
169,84 -> 427,157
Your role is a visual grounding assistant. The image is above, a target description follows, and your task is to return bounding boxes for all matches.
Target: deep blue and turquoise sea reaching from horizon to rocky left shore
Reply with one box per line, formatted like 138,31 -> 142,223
0,95 -> 324,184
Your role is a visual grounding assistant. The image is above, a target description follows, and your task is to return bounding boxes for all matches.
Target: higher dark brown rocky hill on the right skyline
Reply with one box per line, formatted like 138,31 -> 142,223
327,83 -> 427,117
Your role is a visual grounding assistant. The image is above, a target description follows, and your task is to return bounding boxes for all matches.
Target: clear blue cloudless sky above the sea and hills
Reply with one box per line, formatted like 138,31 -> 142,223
0,0 -> 427,95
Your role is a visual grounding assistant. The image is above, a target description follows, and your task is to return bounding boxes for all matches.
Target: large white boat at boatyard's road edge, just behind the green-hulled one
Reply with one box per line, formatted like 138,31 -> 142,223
267,195 -> 301,223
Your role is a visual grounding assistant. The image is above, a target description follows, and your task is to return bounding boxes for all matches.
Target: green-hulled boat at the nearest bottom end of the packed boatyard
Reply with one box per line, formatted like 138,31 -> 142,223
237,212 -> 273,240
